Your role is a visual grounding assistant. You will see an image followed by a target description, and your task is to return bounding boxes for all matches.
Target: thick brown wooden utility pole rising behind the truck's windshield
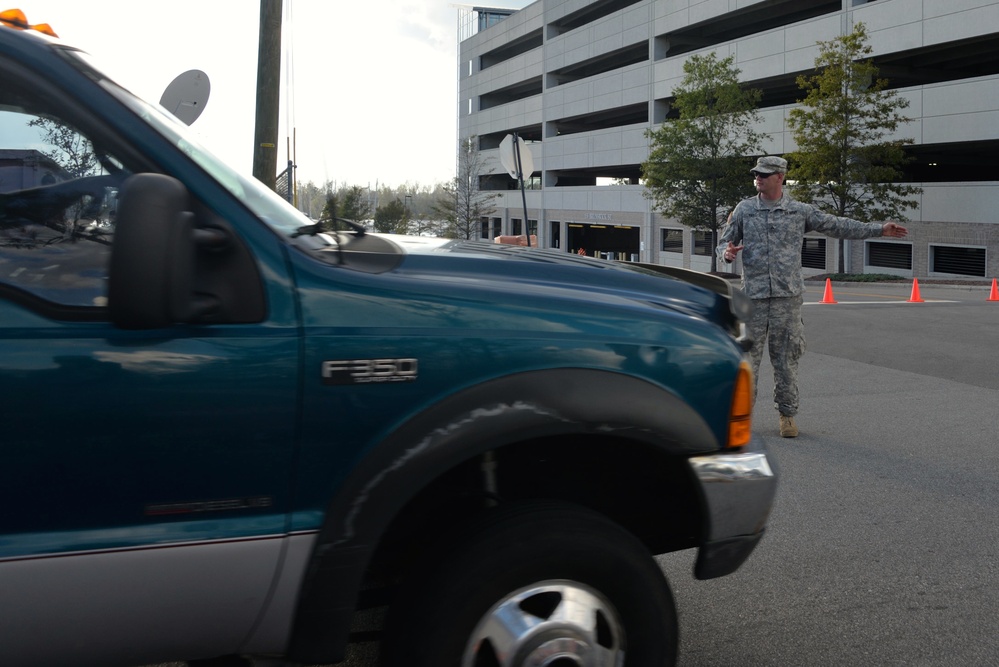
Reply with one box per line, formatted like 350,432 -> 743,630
253,0 -> 283,189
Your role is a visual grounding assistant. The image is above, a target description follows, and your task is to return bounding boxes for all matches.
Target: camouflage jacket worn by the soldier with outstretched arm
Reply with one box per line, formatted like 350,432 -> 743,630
718,193 -> 881,299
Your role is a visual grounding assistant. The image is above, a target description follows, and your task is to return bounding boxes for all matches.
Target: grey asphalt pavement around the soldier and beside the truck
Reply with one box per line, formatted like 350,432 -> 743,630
660,284 -> 999,667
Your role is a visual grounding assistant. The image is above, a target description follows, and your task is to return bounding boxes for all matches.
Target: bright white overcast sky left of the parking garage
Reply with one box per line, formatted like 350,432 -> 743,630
13,0 -> 530,187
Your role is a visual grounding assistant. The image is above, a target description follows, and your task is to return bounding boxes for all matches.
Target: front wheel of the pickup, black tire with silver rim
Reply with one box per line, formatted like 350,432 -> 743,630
381,502 -> 678,667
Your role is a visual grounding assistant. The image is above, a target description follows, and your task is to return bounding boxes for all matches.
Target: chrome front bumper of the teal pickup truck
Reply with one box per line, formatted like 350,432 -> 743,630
689,435 -> 777,579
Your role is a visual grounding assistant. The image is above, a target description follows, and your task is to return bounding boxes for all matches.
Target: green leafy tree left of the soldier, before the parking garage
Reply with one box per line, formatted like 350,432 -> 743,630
642,52 -> 769,271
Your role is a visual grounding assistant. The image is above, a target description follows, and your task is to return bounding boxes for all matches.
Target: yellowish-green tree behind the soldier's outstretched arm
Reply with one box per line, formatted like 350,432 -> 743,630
785,23 -> 922,273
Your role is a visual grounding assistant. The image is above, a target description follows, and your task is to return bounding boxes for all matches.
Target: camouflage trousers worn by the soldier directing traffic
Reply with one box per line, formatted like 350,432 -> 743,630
749,296 -> 805,417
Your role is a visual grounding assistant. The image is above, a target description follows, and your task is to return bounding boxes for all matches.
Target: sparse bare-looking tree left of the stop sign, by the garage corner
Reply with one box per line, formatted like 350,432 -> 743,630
432,136 -> 499,239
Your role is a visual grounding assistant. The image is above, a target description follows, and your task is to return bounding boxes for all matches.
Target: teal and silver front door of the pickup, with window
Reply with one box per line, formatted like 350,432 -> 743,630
0,64 -> 298,664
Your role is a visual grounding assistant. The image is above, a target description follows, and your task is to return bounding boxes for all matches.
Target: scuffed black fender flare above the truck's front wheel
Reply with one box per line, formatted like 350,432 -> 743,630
288,368 -> 719,663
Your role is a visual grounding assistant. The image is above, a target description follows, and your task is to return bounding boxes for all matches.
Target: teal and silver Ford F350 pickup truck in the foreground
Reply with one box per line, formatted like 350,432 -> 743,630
0,11 -> 777,667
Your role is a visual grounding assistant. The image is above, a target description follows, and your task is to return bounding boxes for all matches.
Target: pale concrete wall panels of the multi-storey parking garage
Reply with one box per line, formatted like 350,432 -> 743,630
459,0 -> 999,274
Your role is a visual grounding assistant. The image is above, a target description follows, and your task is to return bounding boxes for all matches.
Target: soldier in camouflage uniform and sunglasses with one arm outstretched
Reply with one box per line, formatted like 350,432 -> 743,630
718,156 -> 908,438
